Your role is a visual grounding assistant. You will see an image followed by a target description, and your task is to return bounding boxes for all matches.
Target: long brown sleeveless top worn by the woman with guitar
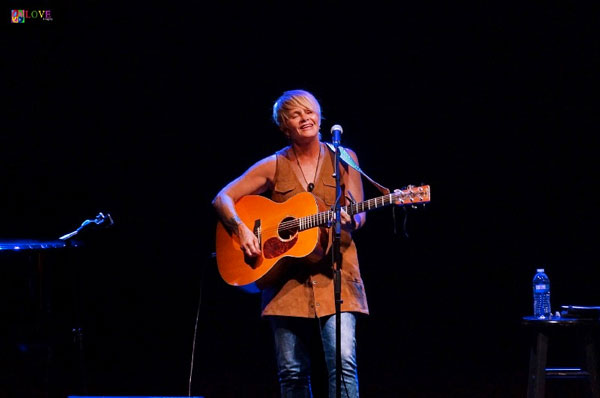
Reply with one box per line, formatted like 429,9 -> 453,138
262,145 -> 369,318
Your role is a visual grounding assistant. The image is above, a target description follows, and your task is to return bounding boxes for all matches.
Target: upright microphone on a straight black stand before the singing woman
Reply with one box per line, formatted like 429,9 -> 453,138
331,125 -> 342,398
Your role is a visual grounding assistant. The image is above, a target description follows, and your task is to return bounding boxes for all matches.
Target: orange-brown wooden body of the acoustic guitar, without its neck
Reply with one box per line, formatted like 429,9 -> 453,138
216,192 -> 328,293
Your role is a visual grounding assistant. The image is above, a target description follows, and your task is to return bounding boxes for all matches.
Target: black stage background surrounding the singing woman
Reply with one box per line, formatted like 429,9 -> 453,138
0,0 -> 600,398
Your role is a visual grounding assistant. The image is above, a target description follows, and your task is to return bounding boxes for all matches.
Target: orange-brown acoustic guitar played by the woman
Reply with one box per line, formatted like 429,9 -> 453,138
216,185 -> 430,293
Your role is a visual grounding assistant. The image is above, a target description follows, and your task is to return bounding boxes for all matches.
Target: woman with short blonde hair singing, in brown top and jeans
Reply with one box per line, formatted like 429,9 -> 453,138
213,90 -> 368,398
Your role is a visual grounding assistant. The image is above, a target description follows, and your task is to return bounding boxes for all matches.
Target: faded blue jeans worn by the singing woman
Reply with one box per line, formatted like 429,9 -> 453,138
270,312 -> 358,398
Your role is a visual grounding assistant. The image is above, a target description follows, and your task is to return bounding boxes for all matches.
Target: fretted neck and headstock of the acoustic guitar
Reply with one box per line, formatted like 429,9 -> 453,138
297,185 -> 429,231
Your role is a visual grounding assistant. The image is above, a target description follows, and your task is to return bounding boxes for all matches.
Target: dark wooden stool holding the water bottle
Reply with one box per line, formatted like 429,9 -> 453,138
522,316 -> 600,398
